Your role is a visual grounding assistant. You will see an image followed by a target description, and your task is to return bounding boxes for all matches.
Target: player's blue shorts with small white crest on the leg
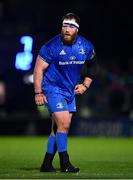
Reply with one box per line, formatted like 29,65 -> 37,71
45,97 -> 76,113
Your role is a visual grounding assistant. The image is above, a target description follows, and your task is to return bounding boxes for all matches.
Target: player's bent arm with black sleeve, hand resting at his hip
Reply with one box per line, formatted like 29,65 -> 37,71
75,51 -> 97,94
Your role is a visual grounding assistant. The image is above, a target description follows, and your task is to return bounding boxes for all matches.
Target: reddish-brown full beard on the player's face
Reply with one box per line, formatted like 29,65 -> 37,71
61,31 -> 77,45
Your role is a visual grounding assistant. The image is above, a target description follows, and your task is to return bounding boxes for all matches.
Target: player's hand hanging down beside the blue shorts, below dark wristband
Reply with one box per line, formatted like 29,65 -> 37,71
35,94 -> 47,106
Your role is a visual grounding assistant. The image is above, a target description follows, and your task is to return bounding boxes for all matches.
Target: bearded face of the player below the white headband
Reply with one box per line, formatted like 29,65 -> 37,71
61,20 -> 78,44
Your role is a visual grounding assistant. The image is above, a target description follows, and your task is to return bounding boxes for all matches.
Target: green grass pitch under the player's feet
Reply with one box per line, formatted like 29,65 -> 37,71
0,136 -> 133,179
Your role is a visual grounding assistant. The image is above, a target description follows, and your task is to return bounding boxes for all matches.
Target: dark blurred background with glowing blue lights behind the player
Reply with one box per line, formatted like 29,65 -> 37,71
0,0 -> 133,136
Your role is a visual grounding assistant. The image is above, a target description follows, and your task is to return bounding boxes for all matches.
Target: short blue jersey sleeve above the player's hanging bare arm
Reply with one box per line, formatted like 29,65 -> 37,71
38,45 -> 52,64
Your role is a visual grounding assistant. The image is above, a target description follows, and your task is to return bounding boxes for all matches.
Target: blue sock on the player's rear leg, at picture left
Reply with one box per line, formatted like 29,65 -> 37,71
47,134 -> 56,154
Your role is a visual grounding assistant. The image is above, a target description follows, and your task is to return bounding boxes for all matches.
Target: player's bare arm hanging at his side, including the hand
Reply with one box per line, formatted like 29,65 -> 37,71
33,56 -> 49,106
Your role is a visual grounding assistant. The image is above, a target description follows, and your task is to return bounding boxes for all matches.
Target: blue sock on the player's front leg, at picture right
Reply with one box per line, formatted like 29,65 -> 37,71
56,132 -> 67,152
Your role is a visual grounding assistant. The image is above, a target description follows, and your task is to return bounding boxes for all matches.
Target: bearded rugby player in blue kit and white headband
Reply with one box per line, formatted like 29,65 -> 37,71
34,13 -> 96,173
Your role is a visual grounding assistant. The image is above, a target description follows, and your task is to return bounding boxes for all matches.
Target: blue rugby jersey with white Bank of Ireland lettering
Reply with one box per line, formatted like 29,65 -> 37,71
39,34 -> 94,101
